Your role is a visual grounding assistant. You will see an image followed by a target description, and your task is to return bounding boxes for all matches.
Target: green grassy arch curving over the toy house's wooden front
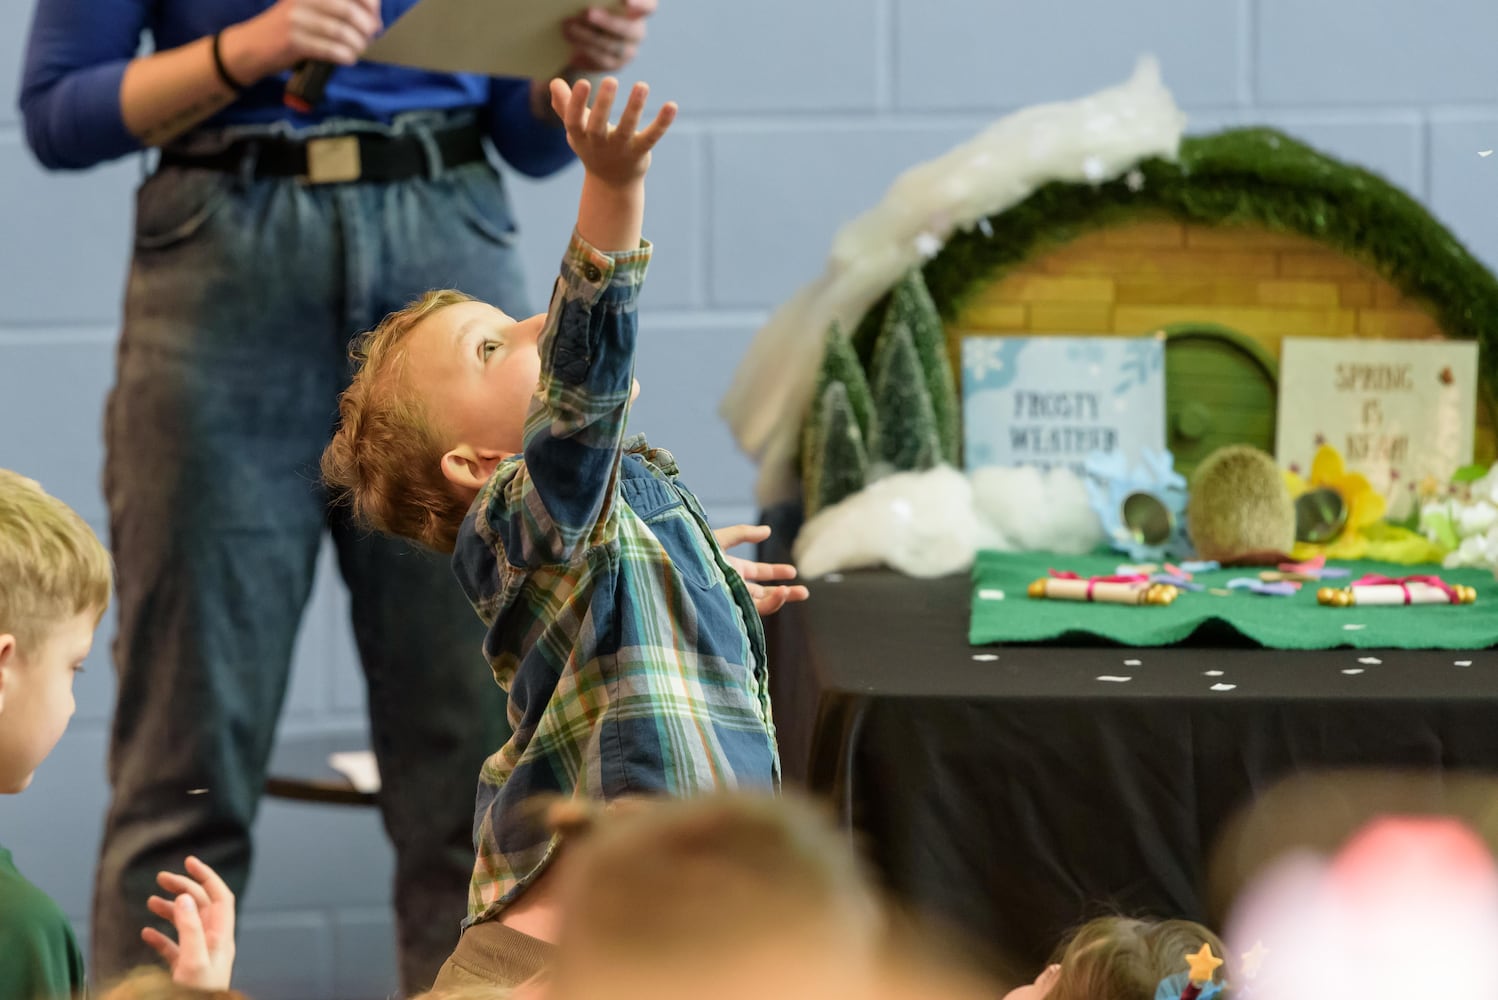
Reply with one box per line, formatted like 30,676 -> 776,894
922,129 -> 1498,377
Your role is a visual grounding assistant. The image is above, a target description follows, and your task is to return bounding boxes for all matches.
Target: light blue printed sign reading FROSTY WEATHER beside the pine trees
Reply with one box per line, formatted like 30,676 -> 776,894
962,335 -> 1165,475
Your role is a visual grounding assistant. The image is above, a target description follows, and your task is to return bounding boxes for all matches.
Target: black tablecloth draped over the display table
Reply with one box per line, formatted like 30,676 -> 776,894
765,572 -> 1498,966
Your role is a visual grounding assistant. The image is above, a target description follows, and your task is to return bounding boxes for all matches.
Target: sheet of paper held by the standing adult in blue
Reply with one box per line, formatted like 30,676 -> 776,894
364,0 -> 598,79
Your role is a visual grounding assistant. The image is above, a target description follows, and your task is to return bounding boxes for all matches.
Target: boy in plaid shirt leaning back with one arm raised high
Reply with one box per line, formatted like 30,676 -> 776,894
322,79 -> 804,985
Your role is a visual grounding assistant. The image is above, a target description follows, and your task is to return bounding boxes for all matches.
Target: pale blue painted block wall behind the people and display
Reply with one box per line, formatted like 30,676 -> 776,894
0,0 -> 1498,1000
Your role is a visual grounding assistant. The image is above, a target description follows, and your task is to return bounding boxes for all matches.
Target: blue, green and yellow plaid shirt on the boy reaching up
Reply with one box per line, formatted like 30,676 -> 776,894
452,235 -> 780,924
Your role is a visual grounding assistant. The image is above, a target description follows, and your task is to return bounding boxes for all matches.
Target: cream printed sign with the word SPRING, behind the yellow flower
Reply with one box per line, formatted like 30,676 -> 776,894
1275,337 -> 1477,519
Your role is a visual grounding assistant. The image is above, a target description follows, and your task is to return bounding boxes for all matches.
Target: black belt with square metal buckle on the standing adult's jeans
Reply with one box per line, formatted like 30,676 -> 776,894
160,124 -> 484,184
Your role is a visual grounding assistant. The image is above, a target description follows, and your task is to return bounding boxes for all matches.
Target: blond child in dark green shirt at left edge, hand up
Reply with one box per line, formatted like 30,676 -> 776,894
0,469 -> 234,1000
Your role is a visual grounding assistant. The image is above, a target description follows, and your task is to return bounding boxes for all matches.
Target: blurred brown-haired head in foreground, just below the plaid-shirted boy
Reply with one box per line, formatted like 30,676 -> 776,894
545,795 -> 885,1000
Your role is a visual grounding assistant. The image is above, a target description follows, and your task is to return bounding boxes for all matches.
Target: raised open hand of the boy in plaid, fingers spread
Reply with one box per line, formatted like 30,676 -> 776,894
551,76 -> 676,186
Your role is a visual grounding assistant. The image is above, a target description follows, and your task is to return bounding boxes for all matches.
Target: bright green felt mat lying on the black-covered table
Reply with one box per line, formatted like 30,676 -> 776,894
968,552 -> 1498,650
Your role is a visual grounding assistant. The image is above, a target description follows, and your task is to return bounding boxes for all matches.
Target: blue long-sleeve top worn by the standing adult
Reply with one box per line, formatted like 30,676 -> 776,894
19,0 -> 572,177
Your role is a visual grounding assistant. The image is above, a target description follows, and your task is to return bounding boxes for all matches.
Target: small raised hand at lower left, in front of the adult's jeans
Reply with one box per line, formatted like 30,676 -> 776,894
141,858 -> 234,990
